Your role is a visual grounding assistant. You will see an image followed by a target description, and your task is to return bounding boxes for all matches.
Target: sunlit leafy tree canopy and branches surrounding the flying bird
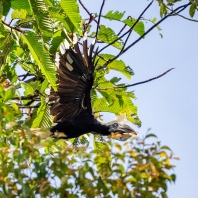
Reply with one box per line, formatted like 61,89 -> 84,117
0,0 -> 198,197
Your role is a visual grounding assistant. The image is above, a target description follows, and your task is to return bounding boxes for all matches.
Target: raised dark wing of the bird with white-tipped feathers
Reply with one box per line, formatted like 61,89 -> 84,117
50,38 -> 96,122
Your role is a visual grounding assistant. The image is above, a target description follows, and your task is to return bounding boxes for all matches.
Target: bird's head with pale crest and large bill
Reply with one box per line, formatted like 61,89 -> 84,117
107,115 -> 137,141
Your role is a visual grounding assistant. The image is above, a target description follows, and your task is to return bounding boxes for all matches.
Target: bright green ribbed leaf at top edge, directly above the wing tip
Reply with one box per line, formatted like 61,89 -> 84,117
60,0 -> 81,33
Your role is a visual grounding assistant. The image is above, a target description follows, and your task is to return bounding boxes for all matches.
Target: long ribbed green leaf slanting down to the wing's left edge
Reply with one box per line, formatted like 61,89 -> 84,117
22,32 -> 57,91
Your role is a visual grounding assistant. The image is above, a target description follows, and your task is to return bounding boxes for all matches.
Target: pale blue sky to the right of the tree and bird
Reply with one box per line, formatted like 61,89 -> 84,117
80,0 -> 198,198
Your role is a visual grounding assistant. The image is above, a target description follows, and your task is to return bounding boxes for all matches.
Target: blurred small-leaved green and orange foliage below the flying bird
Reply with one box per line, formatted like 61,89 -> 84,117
0,128 -> 176,198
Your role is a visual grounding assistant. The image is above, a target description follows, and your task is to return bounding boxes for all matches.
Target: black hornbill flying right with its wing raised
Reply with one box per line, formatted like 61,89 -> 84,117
50,36 -> 136,140
